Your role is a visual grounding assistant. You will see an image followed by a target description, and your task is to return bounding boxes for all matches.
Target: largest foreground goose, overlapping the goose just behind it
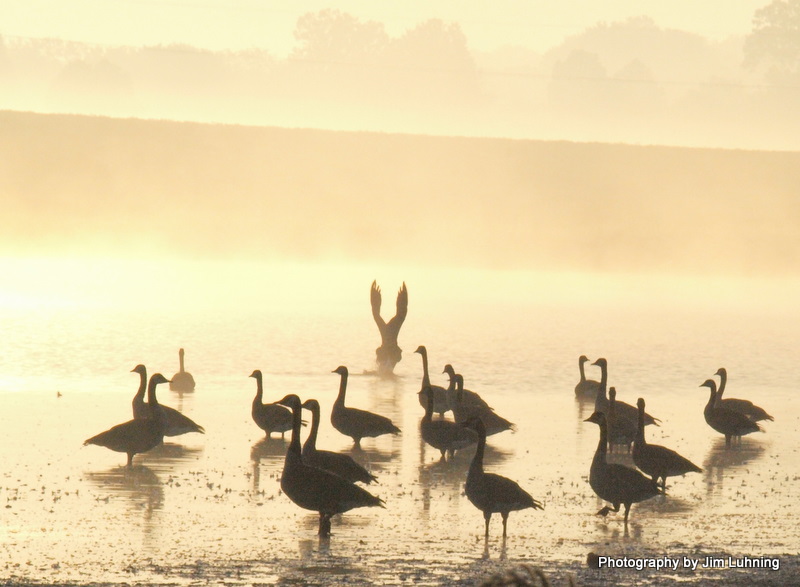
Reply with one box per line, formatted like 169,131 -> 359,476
275,394 -> 385,537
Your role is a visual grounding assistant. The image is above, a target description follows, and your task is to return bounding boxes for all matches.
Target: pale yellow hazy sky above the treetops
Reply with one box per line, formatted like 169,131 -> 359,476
0,0 -> 770,57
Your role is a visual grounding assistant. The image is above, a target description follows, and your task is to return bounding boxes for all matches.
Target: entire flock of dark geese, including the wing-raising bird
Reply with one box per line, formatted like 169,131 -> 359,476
84,294 -> 773,538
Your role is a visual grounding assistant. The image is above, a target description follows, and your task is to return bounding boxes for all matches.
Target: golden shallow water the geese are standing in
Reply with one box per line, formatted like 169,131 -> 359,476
0,279 -> 800,585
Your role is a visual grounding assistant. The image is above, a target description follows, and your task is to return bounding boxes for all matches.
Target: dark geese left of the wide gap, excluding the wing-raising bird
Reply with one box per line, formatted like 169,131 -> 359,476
84,346 -> 543,537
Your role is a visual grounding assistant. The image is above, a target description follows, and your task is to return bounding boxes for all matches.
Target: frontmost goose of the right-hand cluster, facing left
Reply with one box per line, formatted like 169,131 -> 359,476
584,410 -> 663,526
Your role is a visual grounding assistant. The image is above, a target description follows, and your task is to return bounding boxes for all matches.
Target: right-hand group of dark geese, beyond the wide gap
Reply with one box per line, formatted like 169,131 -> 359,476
575,355 -> 773,524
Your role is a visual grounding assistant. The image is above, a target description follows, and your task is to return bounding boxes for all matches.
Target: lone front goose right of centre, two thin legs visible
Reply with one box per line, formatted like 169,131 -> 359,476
463,418 -> 544,538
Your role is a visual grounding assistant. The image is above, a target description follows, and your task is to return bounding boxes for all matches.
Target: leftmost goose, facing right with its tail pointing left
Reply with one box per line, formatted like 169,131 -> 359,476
83,373 -> 169,468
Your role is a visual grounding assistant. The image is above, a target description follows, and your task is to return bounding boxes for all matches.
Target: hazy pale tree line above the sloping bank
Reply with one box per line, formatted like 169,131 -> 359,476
0,0 -> 800,149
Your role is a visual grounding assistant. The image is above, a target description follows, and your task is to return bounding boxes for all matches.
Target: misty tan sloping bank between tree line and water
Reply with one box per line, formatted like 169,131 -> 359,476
0,112 -> 800,282
